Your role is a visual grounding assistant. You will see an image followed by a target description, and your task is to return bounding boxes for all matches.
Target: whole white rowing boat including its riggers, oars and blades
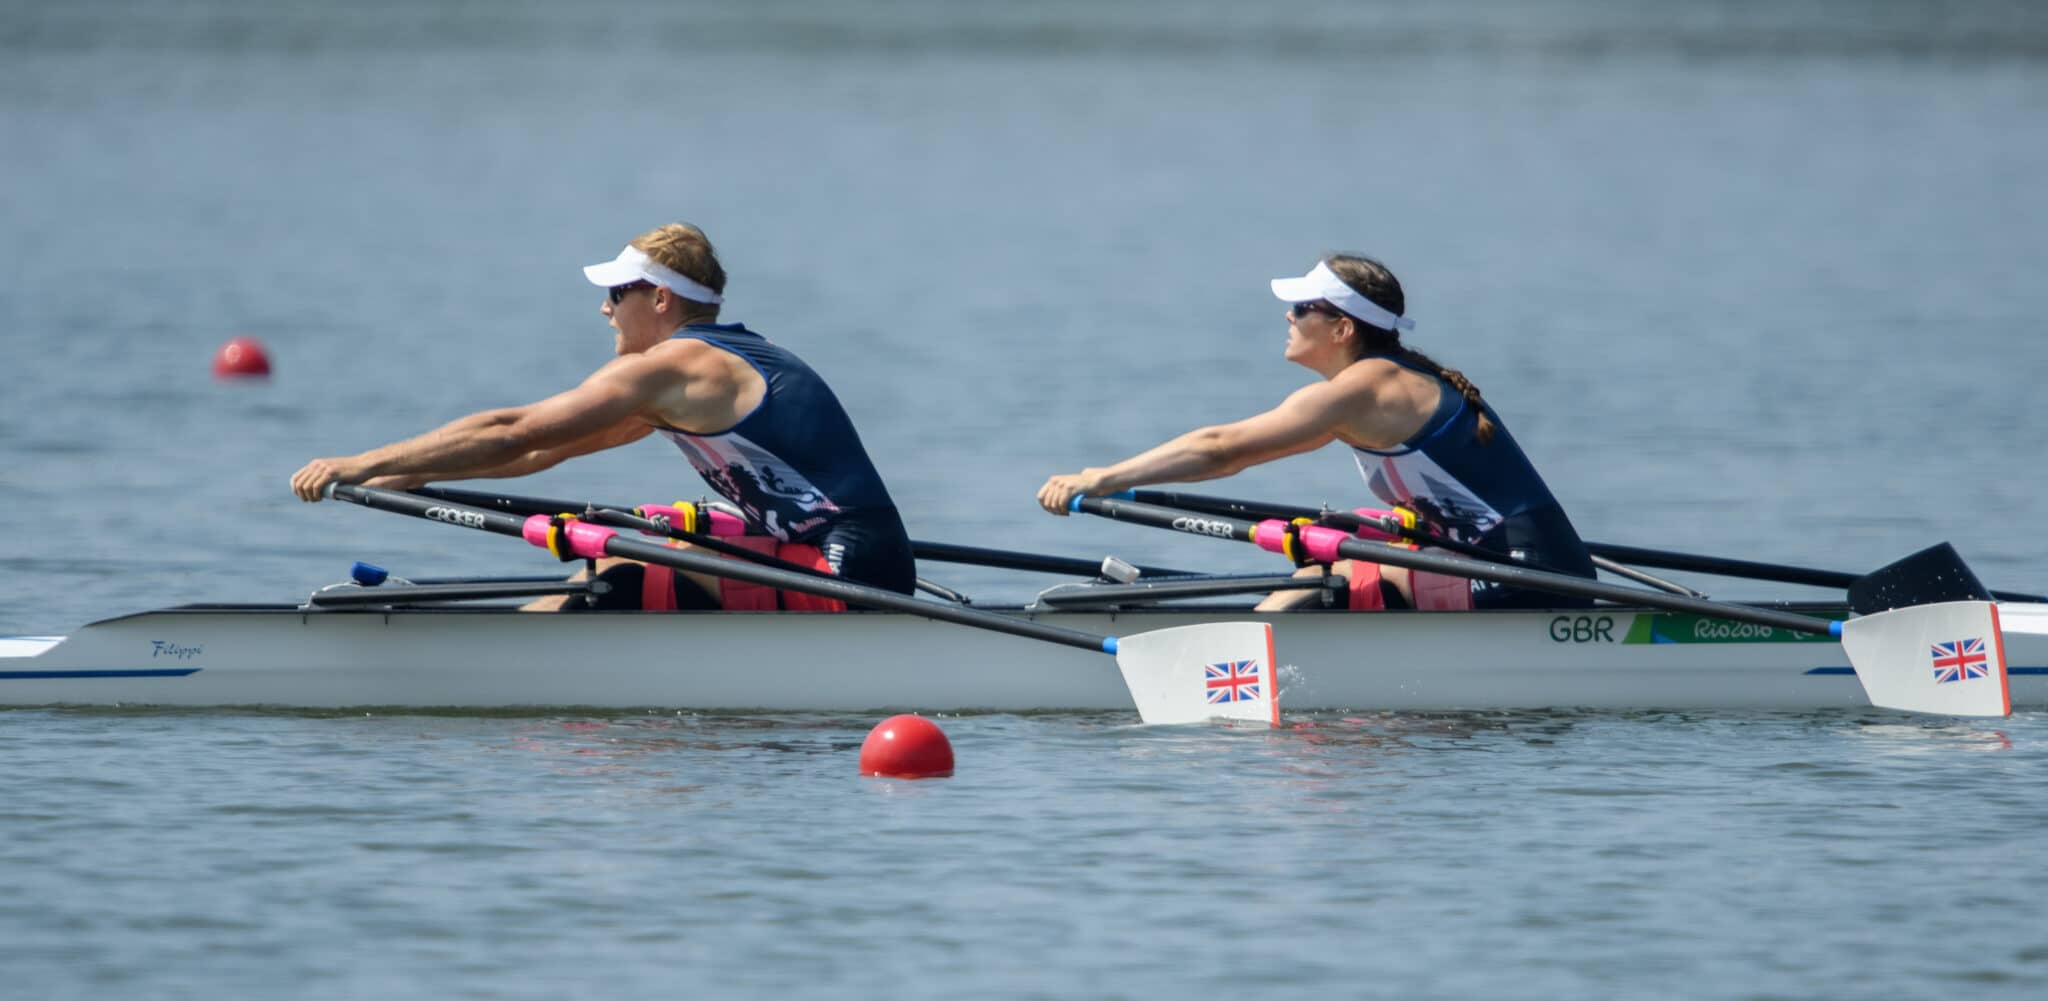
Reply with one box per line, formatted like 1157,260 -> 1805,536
12,485 -> 2048,723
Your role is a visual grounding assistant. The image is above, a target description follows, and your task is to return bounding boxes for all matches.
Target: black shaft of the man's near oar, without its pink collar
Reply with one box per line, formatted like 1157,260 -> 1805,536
334,483 -> 1116,653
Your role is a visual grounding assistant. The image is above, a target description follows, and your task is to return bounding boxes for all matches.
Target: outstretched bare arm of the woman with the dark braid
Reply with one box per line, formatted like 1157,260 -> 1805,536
1038,383 -> 1360,514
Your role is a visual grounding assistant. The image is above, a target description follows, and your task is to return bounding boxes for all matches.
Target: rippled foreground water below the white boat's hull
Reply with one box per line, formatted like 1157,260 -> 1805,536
0,712 -> 2048,999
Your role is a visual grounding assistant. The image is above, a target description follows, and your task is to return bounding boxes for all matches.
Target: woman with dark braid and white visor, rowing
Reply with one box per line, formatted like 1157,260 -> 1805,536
1038,256 -> 1593,610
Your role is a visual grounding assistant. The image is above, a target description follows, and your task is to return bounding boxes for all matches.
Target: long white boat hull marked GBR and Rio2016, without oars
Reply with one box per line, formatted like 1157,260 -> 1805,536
0,604 -> 2048,712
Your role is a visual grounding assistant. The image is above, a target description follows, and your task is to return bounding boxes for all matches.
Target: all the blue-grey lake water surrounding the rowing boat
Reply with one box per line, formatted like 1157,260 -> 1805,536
0,0 -> 2048,999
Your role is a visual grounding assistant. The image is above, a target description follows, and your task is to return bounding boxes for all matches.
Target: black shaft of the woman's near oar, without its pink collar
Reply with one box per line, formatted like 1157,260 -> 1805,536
1075,497 -> 1835,637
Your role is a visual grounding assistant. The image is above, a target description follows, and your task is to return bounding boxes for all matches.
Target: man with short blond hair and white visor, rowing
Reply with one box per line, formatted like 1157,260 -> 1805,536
291,223 -> 915,610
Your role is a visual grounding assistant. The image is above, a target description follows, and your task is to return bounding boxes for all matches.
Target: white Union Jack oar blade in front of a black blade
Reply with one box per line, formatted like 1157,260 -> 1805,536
1841,602 -> 2013,716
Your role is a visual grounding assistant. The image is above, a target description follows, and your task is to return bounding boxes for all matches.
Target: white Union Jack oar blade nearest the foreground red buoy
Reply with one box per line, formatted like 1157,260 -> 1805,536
1116,622 -> 1280,727
